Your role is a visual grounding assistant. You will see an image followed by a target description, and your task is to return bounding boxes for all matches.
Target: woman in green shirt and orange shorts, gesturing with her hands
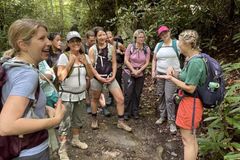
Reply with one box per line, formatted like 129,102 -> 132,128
157,30 -> 207,160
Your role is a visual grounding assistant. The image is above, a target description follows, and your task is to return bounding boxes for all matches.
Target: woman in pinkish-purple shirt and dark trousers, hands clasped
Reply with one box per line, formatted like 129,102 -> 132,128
123,29 -> 150,120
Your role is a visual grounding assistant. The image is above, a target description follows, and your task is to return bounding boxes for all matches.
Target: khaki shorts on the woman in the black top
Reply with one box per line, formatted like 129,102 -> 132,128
90,78 -> 120,91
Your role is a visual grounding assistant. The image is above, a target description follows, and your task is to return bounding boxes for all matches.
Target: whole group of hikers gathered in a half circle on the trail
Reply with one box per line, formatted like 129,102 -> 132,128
0,19 -> 206,160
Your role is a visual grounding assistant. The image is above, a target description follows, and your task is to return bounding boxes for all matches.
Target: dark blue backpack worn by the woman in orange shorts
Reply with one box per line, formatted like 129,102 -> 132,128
196,53 -> 225,108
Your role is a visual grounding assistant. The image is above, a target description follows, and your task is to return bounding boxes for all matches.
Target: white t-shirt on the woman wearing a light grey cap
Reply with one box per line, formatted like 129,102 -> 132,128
58,54 -> 90,102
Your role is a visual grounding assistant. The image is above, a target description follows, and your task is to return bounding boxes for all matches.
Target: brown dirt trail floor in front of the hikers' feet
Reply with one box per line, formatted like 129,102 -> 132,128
54,76 -> 183,160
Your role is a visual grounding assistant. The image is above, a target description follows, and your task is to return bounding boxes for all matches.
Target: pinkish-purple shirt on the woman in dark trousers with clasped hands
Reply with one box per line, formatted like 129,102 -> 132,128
125,44 -> 151,73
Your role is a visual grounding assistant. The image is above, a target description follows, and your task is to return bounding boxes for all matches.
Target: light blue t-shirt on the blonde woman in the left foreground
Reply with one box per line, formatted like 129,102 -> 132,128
1,62 -> 48,157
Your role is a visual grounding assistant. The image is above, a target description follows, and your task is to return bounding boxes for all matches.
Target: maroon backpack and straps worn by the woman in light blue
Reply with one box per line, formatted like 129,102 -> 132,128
0,59 -> 48,160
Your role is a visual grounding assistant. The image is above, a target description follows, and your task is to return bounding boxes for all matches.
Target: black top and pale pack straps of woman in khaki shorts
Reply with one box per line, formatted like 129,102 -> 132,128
93,43 -> 113,78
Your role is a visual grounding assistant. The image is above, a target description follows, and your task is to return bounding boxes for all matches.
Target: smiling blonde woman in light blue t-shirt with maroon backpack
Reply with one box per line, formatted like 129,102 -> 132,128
0,19 -> 65,160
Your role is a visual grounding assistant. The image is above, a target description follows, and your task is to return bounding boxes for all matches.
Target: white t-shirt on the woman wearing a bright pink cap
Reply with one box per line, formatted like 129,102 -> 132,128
154,39 -> 181,73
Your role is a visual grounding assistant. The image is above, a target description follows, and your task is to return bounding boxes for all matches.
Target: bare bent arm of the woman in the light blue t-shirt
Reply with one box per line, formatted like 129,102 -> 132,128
0,96 -> 65,136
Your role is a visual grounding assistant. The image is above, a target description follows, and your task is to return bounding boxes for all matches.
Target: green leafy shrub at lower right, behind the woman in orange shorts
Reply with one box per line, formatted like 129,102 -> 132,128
199,63 -> 240,160
